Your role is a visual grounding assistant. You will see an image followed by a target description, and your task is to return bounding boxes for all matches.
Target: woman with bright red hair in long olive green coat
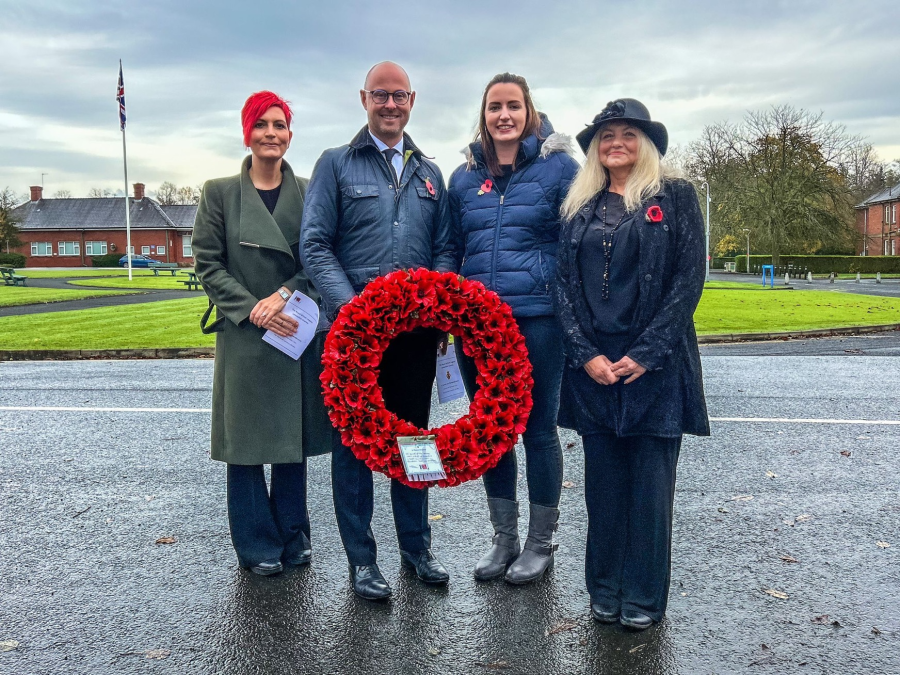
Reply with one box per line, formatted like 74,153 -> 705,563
192,91 -> 331,575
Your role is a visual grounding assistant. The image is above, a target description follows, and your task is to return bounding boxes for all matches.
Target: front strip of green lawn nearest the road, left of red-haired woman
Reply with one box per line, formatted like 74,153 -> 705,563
0,295 -> 215,349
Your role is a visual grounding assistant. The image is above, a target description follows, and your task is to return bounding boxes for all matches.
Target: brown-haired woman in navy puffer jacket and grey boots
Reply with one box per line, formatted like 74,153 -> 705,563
449,73 -> 578,584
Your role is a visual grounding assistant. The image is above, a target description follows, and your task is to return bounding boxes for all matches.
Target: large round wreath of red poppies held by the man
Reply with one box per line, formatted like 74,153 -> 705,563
320,269 -> 533,487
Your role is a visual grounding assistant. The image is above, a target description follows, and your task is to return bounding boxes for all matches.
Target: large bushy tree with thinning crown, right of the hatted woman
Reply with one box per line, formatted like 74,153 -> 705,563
688,106 -> 866,264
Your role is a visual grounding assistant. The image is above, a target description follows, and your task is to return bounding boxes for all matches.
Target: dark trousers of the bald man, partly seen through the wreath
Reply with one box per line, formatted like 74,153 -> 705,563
331,329 -> 440,565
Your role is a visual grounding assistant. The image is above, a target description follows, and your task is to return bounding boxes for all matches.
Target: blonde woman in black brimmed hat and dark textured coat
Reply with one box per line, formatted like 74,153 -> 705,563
555,98 -> 709,630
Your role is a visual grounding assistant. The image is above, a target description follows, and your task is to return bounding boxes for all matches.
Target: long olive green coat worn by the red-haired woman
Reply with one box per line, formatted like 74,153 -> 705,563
191,156 -> 331,464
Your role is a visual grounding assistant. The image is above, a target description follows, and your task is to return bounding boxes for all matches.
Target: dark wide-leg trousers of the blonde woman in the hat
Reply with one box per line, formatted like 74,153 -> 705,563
582,434 -> 681,621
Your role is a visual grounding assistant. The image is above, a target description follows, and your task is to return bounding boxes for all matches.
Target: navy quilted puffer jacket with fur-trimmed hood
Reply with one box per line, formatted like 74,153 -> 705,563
448,115 -> 578,317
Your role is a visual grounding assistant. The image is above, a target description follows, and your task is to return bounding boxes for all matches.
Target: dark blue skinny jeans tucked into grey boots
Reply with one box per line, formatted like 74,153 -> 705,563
455,316 -> 565,508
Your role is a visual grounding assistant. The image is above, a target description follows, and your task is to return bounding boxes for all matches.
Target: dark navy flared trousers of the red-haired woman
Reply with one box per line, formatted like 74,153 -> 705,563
226,462 -> 309,567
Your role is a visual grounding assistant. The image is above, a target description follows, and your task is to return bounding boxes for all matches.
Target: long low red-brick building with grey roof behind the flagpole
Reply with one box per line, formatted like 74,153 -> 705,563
10,183 -> 197,267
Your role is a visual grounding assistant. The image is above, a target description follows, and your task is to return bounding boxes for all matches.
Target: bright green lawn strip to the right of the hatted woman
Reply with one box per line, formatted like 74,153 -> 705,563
694,289 -> 900,334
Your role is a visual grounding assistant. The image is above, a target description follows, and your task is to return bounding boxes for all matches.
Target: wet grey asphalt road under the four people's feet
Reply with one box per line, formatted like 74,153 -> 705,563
0,334 -> 900,675
